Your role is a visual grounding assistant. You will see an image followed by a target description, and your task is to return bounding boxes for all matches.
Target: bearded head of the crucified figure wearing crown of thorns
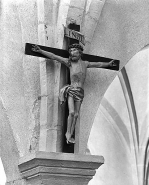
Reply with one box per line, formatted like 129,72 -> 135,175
68,43 -> 83,61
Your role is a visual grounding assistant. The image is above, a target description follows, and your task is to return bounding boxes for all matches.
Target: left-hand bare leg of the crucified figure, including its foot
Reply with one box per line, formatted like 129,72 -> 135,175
65,96 -> 74,142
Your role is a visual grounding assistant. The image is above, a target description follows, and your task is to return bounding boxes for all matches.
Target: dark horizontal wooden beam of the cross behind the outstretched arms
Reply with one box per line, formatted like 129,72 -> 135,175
25,43 -> 120,71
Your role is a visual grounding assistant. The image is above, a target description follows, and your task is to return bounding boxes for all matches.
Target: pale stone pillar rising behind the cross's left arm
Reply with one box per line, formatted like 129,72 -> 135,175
37,0 -> 70,152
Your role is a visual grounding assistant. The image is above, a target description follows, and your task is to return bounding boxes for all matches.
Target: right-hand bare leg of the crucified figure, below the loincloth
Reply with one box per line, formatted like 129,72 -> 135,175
70,101 -> 82,141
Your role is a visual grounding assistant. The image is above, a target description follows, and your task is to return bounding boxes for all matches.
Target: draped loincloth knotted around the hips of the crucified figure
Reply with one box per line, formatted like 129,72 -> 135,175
59,85 -> 84,104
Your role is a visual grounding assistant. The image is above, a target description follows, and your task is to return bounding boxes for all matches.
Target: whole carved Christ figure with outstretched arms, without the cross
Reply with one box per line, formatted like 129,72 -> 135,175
32,44 -> 116,144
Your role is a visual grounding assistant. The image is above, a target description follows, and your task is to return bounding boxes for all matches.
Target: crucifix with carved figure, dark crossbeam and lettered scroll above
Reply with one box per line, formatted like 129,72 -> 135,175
25,22 -> 119,144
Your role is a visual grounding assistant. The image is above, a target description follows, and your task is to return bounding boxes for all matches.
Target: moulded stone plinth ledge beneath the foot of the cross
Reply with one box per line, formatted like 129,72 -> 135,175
19,152 -> 104,185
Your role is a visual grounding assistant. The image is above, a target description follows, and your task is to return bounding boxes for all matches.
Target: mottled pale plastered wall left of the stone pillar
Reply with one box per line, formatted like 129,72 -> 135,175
0,0 -> 40,182
